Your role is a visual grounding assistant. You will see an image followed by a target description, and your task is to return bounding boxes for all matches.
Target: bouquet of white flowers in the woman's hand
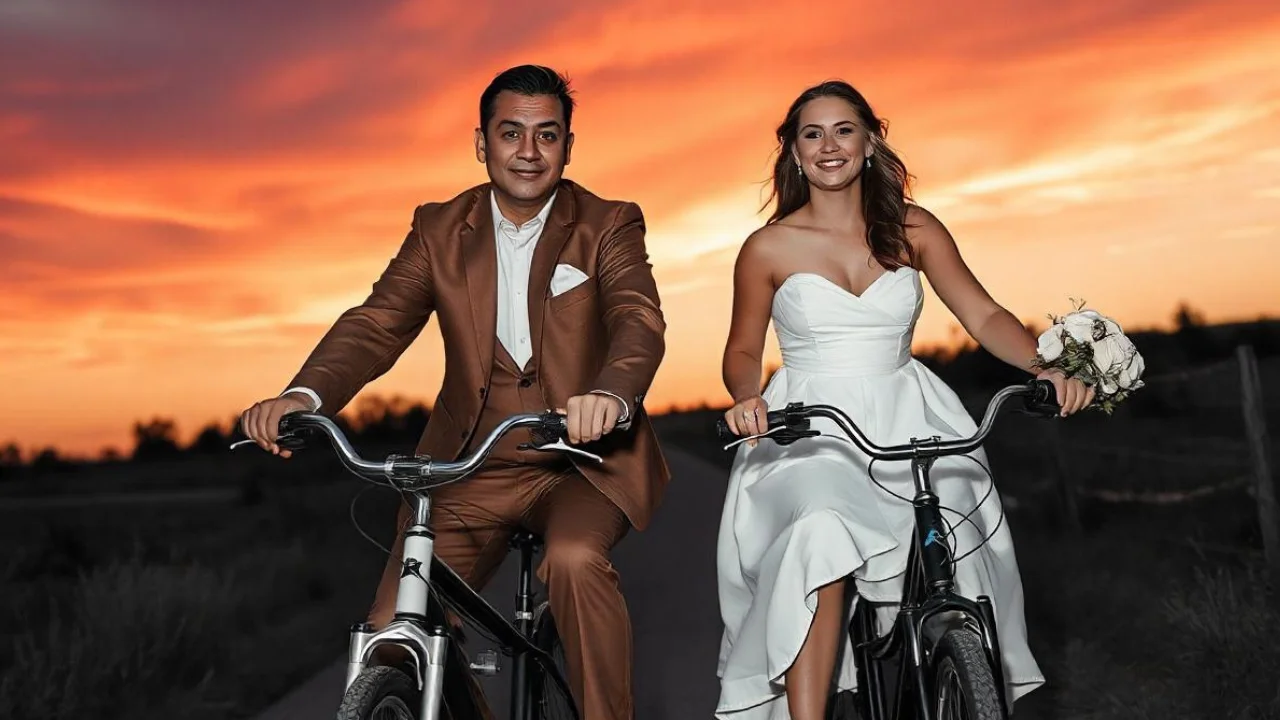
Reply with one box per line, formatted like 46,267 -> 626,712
1036,302 -> 1146,415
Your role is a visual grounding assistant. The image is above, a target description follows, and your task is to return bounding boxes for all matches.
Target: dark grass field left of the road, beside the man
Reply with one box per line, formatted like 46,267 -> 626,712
0,450 -> 394,720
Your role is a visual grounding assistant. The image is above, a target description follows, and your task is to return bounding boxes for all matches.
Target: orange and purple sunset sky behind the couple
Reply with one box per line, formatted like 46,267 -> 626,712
0,0 -> 1280,455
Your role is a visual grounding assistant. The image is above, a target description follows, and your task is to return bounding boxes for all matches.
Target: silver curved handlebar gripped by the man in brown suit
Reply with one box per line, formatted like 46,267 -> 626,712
232,411 -> 581,491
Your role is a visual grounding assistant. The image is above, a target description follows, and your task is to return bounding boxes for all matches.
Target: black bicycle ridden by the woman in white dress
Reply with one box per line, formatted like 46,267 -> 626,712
717,380 -> 1060,720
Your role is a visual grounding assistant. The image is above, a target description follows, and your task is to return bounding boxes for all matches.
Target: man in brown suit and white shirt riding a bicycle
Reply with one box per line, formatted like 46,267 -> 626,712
242,65 -> 669,720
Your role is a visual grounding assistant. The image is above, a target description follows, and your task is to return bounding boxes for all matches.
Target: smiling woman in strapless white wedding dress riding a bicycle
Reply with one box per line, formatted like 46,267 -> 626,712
717,82 -> 1093,720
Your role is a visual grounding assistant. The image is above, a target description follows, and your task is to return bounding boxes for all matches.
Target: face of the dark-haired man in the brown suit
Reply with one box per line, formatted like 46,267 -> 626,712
476,91 -> 573,205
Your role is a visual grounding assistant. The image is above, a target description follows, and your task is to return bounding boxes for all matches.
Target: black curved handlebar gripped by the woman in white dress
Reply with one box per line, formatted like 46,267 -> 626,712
716,380 -> 1061,461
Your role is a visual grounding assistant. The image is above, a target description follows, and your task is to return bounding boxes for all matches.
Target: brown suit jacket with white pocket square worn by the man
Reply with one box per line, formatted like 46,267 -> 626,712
287,181 -> 669,529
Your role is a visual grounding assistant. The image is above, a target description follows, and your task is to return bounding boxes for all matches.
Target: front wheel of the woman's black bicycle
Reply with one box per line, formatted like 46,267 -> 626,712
932,629 -> 1005,720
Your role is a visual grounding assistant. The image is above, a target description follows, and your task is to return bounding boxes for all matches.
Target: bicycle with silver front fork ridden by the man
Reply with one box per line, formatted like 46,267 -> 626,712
232,413 -> 586,720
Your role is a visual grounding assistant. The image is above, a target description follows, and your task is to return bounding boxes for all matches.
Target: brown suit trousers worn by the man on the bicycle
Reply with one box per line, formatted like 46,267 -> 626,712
370,464 -> 634,720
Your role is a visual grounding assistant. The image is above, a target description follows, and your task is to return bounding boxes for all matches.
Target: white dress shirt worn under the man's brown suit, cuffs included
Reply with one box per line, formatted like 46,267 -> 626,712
288,192 -> 631,424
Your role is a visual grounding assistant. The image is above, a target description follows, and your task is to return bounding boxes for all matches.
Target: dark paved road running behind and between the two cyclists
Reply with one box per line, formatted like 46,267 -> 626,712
259,445 -> 726,720
